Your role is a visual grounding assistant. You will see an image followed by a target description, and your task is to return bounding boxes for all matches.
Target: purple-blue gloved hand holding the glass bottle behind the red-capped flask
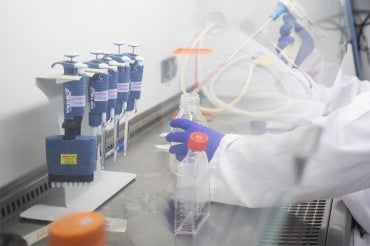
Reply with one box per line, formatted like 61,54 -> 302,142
166,119 -> 225,161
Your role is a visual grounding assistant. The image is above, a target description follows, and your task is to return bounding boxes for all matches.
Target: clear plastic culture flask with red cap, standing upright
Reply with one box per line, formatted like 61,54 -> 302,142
174,132 -> 210,236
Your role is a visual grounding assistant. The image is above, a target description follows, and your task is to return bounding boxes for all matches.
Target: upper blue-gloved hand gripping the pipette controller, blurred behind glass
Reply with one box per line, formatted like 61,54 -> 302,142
277,14 -> 315,66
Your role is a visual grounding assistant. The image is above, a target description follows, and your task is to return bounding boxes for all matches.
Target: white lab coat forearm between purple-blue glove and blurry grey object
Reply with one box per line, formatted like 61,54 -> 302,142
211,128 -> 314,207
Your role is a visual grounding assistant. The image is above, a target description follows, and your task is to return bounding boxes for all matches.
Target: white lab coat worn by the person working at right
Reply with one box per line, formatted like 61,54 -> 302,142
211,70 -> 370,246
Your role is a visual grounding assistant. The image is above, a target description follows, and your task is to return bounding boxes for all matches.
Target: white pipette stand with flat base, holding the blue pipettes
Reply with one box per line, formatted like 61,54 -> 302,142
20,78 -> 136,221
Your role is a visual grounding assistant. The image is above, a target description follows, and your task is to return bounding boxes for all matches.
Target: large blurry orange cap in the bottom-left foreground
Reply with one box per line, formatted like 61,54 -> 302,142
49,212 -> 106,246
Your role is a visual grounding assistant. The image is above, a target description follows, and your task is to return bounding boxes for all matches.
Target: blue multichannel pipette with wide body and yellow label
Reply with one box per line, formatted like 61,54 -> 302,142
46,53 -> 97,186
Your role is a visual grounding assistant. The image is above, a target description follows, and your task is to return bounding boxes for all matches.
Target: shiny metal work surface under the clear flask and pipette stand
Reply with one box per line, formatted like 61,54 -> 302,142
1,112 -> 350,246
